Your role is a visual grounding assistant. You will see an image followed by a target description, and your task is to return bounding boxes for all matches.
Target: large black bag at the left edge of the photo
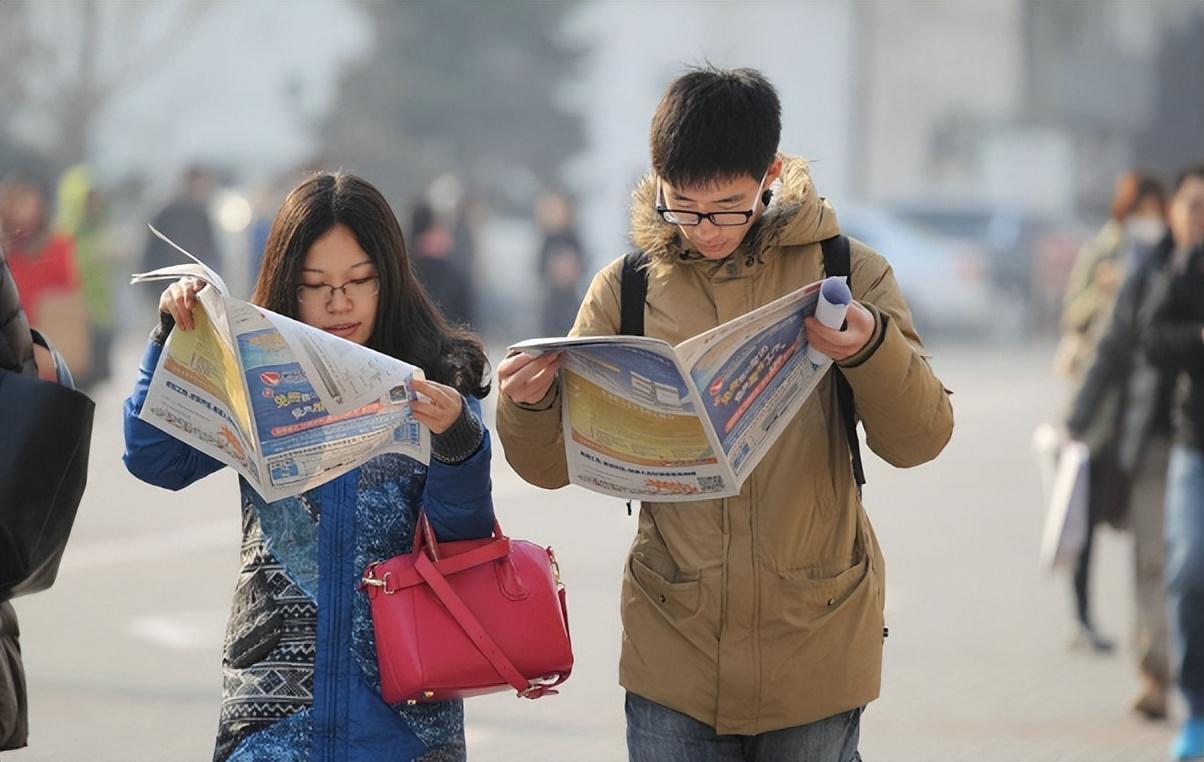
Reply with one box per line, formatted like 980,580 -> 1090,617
0,370 -> 95,601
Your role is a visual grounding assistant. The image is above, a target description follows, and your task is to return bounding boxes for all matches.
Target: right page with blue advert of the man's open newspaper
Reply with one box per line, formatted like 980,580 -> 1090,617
677,282 -> 832,482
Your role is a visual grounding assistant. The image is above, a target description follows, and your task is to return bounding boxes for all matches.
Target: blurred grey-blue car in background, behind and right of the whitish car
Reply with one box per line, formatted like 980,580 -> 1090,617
892,203 -> 1088,332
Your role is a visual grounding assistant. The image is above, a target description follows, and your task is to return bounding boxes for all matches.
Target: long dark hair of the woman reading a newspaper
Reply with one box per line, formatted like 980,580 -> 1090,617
252,172 -> 489,397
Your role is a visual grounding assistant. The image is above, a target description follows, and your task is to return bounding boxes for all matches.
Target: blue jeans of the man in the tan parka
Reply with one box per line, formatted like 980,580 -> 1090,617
627,692 -> 862,762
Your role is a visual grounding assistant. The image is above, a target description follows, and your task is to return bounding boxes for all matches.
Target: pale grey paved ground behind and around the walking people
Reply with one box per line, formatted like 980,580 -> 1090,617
4,344 -> 1171,762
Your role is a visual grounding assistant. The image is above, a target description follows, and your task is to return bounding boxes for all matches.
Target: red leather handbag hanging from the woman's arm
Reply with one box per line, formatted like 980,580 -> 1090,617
361,513 -> 573,704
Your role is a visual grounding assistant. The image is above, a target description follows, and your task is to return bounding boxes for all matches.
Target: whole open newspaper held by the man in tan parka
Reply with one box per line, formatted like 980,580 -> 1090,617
510,278 -> 848,501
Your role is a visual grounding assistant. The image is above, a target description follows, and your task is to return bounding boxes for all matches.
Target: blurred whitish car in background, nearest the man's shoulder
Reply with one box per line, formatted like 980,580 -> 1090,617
837,201 -> 1001,337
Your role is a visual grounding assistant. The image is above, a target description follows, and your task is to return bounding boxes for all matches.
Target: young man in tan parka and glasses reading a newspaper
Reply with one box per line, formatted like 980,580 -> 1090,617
497,69 -> 952,762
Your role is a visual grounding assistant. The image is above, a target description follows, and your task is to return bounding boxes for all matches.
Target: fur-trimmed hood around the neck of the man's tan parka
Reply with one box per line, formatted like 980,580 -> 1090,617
631,155 -> 840,264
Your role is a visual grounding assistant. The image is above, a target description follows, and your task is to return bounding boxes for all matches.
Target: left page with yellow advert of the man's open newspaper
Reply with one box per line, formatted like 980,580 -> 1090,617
515,336 -> 739,501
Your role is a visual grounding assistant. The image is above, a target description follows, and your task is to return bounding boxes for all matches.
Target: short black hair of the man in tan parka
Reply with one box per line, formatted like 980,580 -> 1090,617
651,66 -> 781,188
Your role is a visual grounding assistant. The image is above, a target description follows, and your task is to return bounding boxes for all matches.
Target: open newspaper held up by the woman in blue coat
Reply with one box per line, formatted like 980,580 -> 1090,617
131,229 -> 431,501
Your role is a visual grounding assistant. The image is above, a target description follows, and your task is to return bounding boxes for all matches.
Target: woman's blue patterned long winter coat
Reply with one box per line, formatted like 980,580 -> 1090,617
125,342 -> 494,762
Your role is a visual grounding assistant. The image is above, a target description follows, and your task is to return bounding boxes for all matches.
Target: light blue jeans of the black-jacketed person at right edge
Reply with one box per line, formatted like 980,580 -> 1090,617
1167,444 -> 1204,719
